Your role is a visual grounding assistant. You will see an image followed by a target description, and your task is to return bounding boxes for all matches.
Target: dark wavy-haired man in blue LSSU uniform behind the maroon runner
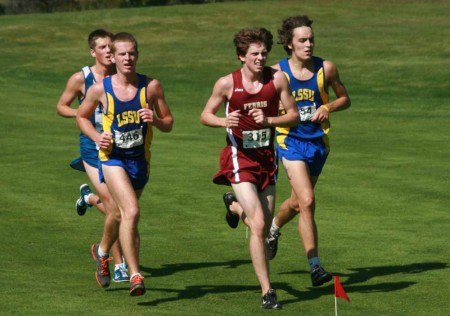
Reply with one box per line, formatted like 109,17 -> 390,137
266,16 -> 350,286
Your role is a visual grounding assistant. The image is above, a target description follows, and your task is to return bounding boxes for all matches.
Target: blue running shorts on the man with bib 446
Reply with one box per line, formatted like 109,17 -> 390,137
98,157 -> 150,190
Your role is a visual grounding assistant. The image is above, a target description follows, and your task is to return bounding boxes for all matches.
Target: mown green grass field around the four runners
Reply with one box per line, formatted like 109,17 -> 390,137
0,0 -> 450,315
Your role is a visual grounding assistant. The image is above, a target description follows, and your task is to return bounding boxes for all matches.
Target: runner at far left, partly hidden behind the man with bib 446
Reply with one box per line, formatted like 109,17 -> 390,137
56,29 -> 129,282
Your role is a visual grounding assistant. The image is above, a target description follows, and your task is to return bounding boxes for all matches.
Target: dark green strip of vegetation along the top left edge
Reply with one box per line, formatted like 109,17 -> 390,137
0,0 -> 242,15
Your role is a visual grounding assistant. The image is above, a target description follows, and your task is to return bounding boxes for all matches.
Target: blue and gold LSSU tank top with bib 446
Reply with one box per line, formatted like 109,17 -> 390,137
99,74 -> 153,161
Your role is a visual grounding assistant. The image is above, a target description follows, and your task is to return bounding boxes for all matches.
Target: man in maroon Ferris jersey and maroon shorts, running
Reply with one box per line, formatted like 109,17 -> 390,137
201,28 -> 299,309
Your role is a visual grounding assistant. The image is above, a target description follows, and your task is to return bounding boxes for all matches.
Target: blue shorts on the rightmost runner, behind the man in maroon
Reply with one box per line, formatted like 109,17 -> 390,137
277,136 -> 329,176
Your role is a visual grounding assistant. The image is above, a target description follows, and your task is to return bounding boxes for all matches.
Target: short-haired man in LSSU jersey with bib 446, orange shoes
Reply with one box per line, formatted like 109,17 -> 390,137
77,32 -> 173,296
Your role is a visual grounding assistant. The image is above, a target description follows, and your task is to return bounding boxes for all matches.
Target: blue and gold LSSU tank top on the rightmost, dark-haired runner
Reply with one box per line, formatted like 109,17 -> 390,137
276,57 -> 330,139
